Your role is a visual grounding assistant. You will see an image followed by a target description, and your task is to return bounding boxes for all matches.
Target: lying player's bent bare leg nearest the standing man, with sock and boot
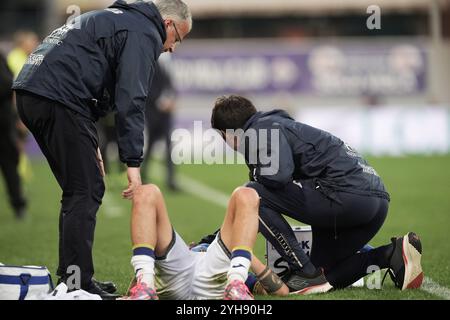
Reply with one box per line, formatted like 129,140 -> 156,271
131,184 -> 173,299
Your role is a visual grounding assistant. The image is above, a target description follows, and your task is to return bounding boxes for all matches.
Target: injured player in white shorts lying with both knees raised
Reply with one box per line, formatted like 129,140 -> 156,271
118,184 -> 289,300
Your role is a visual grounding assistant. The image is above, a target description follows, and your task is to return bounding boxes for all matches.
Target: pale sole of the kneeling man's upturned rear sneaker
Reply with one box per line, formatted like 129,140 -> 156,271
402,232 -> 423,290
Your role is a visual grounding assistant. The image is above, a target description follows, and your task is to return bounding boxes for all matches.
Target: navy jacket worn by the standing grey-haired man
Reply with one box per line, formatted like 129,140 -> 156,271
13,1 -> 166,167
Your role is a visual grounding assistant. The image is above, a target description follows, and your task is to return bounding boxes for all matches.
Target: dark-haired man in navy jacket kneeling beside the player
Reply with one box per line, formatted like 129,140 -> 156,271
211,96 -> 423,294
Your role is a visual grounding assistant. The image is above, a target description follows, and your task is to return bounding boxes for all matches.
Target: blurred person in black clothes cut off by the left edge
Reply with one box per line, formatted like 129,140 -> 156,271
0,53 -> 26,219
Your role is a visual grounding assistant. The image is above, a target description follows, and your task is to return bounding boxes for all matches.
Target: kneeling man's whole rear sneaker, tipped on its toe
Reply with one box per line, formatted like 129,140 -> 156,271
388,232 -> 423,290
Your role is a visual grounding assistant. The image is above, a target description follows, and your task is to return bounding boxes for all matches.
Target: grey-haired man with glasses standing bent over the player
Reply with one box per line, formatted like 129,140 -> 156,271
13,0 -> 192,299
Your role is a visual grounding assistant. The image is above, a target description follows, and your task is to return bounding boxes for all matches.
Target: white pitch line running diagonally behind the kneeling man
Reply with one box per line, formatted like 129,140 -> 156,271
175,174 -> 450,300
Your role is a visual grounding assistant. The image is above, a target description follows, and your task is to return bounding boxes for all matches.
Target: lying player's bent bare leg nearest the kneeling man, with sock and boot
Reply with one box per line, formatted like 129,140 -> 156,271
220,187 -> 259,299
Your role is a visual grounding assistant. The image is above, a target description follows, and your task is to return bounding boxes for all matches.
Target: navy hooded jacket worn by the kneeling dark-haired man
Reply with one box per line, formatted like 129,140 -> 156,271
239,110 -> 389,201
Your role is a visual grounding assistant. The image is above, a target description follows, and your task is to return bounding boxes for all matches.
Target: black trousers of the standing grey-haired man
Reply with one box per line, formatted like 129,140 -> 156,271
17,91 -> 105,289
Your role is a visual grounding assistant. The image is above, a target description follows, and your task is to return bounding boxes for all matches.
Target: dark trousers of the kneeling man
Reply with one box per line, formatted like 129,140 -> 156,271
247,180 -> 391,288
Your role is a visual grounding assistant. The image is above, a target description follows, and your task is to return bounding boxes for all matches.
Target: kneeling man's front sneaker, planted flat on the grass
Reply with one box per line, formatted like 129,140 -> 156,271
283,268 -> 333,295
